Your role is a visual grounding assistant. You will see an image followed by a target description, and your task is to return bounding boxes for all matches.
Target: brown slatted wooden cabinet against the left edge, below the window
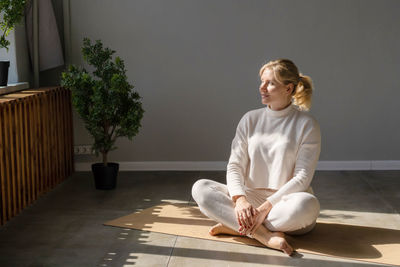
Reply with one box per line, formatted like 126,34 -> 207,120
0,87 -> 74,225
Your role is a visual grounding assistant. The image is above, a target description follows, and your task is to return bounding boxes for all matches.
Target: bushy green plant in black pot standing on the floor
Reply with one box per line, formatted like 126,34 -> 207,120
61,38 -> 144,189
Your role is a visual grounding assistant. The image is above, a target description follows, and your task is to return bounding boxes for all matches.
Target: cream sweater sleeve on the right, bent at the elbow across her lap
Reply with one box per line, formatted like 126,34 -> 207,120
267,120 -> 321,205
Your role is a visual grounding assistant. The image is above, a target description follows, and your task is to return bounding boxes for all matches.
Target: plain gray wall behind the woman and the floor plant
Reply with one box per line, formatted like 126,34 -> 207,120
62,0 -> 400,161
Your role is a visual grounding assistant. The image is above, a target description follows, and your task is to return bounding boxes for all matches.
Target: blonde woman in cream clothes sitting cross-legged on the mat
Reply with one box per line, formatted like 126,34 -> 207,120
192,59 -> 321,255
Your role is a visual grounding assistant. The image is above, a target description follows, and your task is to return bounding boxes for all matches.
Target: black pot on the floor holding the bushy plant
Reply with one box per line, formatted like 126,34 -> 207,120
92,162 -> 119,190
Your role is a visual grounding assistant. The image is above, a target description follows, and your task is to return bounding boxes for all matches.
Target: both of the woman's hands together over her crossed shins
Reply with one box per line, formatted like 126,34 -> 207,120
235,196 -> 269,236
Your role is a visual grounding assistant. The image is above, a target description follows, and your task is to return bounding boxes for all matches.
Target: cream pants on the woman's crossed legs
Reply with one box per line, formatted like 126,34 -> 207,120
192,179 -> 319,234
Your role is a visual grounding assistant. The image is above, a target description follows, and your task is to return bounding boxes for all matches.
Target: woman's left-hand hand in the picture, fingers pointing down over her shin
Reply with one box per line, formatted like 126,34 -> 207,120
235,196 -> 258,234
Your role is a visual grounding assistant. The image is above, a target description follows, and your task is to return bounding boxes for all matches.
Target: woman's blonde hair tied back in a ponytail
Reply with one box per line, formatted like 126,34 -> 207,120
260,59 -> 313,111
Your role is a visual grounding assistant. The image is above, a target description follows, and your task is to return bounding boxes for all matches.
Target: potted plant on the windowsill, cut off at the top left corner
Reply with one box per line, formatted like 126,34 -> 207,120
0,0 -> 26,86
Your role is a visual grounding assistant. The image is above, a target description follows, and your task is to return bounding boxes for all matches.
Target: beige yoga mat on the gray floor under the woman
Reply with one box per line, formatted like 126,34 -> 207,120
105,204 -> 400,265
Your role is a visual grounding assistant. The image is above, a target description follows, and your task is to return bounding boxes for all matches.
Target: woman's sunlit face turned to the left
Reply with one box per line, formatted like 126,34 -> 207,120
260,69 -> 292,110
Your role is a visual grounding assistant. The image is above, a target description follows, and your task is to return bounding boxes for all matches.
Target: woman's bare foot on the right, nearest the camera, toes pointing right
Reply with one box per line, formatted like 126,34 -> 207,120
253,225 -> 293,255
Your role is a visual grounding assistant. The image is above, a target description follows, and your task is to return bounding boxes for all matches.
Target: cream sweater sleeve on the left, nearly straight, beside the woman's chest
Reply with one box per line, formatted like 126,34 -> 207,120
226,115 -> 249,197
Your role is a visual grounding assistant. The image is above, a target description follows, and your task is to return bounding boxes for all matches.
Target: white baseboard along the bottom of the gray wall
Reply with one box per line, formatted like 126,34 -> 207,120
75,160 -> 400,171
